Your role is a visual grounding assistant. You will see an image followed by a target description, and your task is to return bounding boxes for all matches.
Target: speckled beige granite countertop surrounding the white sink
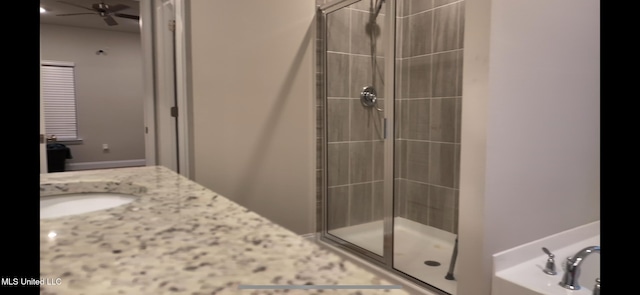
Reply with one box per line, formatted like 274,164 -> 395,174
40,166 -> 407,295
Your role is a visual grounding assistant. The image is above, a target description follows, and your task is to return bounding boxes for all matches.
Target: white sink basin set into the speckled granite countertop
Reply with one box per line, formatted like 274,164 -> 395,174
40,192 -> 138,219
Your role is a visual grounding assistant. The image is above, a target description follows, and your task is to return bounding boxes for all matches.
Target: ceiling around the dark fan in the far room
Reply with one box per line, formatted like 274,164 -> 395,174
40,0 -> 140,33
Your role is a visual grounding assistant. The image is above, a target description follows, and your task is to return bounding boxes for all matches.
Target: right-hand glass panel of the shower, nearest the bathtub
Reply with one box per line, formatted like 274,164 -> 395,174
393,1 -> 464,294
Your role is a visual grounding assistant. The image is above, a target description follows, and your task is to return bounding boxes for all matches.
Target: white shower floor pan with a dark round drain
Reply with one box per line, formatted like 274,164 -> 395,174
329,217 -> 457,294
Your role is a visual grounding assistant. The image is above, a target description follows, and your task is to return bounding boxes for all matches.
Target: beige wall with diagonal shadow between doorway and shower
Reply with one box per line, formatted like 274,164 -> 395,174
188,0 -> 315,234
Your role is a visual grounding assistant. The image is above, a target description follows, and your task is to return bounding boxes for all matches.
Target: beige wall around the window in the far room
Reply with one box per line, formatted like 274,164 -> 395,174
40,24 -> 145,168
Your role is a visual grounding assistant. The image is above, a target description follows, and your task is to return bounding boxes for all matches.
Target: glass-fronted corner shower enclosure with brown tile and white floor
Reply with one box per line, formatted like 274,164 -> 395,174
317,0 -> 464,294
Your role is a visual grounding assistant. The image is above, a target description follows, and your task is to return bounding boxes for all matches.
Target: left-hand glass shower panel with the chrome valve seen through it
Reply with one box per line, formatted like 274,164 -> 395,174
324,0 -> 386,260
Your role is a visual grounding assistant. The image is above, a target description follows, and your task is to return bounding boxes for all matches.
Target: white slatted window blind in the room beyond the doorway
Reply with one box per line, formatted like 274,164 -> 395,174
41,62 -> 78,140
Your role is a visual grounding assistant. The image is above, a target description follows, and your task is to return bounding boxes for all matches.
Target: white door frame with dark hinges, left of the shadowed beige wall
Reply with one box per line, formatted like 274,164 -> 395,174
139,0 -> 192,178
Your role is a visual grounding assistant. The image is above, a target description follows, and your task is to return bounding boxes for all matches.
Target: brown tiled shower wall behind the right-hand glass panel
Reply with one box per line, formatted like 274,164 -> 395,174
394,0 -> 464,233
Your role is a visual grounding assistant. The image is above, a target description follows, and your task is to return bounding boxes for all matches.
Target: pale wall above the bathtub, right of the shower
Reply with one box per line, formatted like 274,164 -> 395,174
457,0 -> 600,295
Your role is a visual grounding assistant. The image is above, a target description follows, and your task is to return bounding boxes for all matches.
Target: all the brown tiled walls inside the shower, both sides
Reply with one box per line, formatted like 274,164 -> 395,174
316,0 -> 464,236
